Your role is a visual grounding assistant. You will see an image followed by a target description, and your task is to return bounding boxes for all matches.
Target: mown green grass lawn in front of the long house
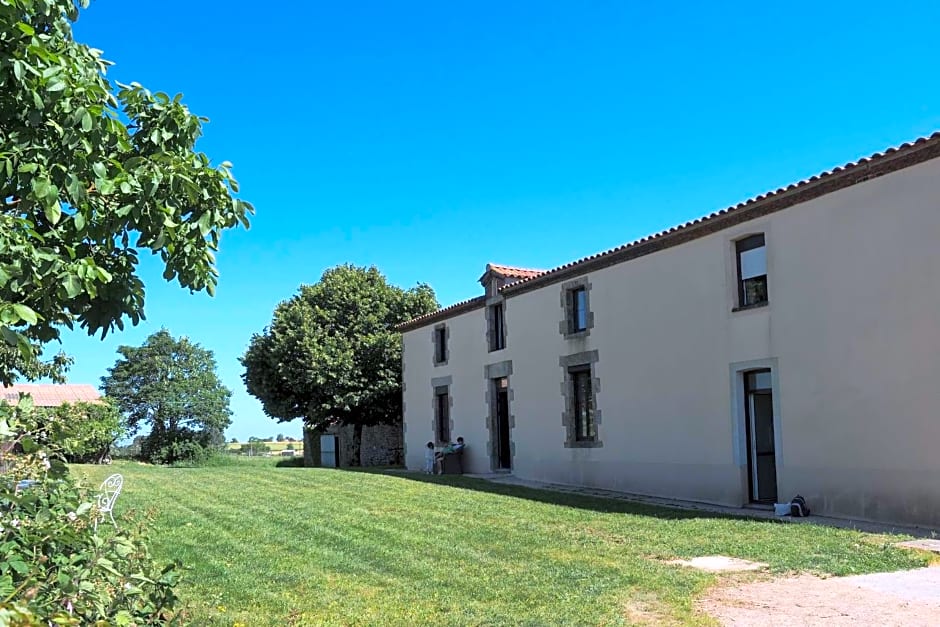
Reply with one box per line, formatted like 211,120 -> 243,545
74,460 -> 924,627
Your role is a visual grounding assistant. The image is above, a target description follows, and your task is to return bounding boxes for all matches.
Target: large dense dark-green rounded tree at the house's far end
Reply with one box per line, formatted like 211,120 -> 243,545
241,265 -> 438,463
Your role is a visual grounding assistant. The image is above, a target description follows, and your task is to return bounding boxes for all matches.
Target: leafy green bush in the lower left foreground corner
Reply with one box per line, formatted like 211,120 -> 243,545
0,397 -> 180,625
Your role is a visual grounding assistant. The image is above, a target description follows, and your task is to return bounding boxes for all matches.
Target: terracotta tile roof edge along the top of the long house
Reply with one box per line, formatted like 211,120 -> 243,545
396,132 -> 940,331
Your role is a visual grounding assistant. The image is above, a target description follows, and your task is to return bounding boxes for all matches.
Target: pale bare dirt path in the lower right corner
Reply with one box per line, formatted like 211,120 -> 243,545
698,567 -> 940,627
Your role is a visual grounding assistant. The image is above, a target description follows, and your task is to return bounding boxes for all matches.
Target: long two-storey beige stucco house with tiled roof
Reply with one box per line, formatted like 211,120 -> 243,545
400,133 -> 940,527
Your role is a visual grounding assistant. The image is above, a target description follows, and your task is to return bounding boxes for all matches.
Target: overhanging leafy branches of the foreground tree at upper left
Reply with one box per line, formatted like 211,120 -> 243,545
0,0 -> 254,384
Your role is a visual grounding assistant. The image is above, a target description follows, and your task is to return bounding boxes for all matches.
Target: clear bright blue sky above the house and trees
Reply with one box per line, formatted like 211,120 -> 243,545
62,0 -> 940,439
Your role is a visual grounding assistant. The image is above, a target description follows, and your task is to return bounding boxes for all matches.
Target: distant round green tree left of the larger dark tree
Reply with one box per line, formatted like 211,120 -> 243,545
101,329 -> 232,464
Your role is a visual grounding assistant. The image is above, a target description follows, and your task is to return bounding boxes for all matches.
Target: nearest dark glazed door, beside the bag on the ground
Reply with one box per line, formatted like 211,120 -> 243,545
744,370 -> 777,503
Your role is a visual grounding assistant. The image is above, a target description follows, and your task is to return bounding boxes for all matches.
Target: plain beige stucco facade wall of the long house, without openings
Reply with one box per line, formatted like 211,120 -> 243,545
404,160 -> 940,526
